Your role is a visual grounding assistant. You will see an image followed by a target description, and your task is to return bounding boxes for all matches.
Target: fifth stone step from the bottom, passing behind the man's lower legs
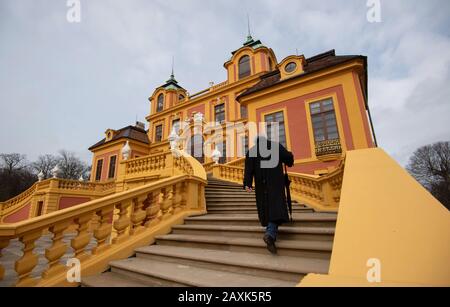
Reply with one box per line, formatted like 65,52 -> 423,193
172,224 -> 334,241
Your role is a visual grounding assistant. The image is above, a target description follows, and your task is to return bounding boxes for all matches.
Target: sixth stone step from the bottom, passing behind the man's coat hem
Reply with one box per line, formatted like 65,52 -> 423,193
185,213 -> 336,227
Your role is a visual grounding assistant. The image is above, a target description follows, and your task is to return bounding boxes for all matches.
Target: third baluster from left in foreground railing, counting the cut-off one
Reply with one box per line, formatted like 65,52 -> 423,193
42,221 -> 70,278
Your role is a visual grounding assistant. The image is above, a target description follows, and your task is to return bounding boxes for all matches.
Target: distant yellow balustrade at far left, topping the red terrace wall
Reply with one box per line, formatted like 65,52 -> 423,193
0,178 -> 116,221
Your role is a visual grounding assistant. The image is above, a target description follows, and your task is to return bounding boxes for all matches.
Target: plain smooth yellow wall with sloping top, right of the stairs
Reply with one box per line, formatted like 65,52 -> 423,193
300,149 -> 450,286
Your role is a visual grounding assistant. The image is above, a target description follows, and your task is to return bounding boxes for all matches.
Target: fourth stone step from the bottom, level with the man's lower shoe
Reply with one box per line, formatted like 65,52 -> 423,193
156,234 -> 333,259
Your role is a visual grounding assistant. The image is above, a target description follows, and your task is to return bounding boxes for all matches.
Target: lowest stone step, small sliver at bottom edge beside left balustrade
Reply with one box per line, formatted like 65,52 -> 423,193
81,272 -> 149,288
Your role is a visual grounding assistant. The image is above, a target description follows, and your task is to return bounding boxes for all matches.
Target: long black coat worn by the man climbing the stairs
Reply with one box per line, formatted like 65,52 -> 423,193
244,141 -> 294,226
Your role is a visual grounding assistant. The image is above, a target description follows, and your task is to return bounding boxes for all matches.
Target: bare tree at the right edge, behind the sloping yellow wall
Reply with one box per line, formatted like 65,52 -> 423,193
406,142 -> 450,209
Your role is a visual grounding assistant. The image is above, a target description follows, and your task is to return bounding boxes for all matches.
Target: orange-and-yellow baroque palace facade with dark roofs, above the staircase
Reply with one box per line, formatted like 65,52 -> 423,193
90,36 -> 376,181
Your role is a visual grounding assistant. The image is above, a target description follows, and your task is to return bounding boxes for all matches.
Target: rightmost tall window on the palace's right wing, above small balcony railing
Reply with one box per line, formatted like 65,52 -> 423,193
309,99 -> 339,143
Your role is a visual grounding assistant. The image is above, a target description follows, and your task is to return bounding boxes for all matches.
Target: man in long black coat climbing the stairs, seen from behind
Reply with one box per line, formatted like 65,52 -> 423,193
244,136 -> 294,254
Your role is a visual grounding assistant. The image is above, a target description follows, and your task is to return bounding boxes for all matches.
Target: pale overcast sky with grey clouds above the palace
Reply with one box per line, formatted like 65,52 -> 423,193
0,0 -> 450,165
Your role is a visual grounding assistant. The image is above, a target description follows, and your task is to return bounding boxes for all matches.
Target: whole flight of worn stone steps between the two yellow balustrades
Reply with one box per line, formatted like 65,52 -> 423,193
82,178 -> 336,287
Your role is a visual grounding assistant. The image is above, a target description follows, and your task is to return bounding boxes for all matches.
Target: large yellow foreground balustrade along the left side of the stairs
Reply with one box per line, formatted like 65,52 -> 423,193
0,152 -> 206,286
